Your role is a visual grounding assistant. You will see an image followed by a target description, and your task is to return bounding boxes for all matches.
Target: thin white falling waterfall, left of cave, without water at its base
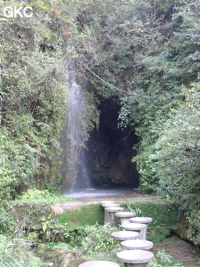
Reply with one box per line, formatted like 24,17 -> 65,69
65,62 -> 90,191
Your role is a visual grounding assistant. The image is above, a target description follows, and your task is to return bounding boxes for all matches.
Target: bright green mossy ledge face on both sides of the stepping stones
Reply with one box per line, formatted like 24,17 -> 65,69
58,201 -> 178,242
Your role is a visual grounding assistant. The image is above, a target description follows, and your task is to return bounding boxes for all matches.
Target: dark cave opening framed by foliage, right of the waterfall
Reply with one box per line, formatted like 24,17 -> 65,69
85,100 -> 139,189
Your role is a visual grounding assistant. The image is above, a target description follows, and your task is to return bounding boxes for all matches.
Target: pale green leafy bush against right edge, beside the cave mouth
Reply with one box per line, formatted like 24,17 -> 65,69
134,82 -> 200,244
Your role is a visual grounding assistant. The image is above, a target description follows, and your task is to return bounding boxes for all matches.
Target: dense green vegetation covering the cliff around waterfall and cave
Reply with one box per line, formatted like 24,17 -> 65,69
0,0 -> 200,266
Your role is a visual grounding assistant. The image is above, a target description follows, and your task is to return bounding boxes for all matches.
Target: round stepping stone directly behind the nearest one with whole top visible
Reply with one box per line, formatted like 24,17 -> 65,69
121,239 -> 153,250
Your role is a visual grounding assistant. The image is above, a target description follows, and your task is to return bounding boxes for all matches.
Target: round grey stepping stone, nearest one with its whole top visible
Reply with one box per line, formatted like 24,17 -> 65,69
117,249 -> 154,267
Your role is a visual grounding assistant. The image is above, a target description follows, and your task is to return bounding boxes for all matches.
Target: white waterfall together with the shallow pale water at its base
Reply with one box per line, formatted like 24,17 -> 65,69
64,61 -> 137,198
